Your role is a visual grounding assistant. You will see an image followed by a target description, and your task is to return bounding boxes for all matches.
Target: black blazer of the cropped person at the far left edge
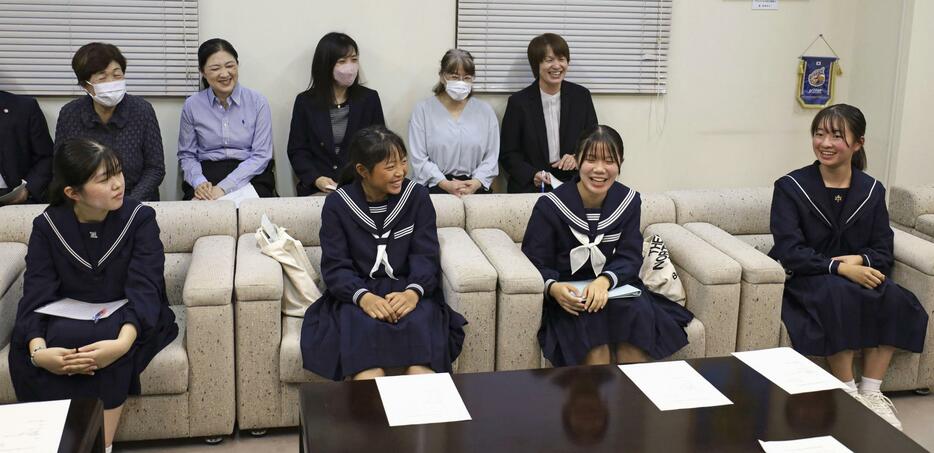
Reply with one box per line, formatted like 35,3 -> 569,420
0,91 -> 52,202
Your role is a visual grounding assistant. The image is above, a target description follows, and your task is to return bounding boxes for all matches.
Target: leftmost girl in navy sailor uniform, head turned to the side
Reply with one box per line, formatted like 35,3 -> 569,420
9,138 -> 178,446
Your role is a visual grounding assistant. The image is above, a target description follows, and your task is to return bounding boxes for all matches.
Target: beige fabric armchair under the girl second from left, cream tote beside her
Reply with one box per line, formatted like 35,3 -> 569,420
234,195 -> 496,429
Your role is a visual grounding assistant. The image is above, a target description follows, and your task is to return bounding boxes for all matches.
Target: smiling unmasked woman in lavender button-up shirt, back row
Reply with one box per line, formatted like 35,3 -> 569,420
178,38 -> 276,200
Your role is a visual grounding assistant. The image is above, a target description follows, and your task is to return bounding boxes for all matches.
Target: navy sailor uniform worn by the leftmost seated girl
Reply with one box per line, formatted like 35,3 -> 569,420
9,199 -> 178,409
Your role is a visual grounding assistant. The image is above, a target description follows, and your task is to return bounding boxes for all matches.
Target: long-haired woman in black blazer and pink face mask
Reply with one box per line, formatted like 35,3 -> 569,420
288,32 -> 385,196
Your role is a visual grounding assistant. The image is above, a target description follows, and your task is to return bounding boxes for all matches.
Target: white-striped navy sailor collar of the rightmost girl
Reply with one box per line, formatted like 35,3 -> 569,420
781,161 -> 882,229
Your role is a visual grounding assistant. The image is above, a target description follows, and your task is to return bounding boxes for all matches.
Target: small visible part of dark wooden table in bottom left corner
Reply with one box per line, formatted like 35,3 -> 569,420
58,399 -> 105,453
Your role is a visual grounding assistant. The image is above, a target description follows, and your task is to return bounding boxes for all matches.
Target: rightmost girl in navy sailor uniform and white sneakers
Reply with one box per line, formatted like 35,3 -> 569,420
769,104 -> 928,428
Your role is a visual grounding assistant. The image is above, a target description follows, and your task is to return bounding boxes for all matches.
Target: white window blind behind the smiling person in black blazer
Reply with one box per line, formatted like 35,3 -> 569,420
456,0 -> 671,93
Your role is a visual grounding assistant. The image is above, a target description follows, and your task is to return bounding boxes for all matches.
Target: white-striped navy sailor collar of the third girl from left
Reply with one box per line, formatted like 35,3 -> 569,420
545,176 -> 637,234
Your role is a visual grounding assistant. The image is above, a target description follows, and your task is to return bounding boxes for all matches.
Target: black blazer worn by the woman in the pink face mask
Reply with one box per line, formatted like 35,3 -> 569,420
288,86 -> 385,196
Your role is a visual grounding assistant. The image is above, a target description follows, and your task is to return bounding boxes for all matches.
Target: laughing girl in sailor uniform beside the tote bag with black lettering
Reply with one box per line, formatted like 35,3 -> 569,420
522,125 -> 693,366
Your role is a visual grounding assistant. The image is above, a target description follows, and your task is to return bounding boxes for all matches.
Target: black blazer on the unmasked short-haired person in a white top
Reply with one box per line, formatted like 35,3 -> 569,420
499,79 -> 597,193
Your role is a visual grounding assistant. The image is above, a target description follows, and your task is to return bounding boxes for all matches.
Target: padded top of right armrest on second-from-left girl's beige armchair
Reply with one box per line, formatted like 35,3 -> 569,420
438,227 -> 496,293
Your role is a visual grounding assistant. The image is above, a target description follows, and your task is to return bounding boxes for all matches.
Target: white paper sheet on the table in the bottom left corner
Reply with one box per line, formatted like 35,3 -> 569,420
0,400 -> 71,453
